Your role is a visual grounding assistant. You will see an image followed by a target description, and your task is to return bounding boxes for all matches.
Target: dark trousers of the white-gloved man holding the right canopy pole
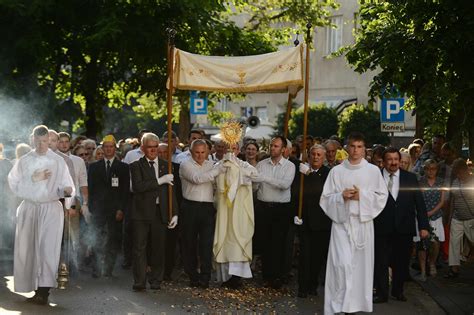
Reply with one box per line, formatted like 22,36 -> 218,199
298,225 -> 331,293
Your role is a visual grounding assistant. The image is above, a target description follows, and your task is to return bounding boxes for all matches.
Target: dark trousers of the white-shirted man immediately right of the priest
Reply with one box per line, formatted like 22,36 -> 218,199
255,201 -> 291,281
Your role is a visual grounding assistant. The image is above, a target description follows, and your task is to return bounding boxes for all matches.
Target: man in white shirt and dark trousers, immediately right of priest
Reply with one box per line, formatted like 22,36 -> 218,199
254,136 -> 295,289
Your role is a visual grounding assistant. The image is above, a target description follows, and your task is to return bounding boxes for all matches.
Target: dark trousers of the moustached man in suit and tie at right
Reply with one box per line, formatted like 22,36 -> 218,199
374,233 -> 413,299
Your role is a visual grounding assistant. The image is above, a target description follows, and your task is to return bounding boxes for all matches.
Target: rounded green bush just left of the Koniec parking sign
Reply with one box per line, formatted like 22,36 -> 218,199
339,105 -> 390,146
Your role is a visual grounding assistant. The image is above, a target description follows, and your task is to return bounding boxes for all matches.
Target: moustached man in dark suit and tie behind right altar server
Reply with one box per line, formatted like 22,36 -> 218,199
374,148 -> 429,303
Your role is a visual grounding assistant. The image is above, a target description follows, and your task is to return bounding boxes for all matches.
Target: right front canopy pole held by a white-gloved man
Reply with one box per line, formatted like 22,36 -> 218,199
296,22 -> 313,219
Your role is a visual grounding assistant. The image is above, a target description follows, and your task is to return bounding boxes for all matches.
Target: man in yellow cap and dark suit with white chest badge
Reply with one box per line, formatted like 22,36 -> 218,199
88,135 -> 130,278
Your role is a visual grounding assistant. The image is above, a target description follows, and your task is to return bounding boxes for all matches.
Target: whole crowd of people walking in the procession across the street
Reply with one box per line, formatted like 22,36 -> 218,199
0,126 -> 474,314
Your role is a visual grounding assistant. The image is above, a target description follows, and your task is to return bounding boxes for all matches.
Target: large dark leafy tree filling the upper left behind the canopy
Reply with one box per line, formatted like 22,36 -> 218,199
0,0 -> 275,137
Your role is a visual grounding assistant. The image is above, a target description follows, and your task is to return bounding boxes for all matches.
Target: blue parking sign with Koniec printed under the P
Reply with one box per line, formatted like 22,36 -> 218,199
380,98 -> 405,132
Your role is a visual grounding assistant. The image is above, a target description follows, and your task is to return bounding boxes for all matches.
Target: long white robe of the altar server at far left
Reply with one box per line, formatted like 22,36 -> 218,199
8,150 -> 74,292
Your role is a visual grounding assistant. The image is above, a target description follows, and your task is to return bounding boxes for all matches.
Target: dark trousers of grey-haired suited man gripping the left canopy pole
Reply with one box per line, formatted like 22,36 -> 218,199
132,207 -> 168,287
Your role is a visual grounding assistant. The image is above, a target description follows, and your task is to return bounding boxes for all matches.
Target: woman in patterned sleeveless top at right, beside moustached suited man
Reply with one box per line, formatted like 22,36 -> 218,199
415,159 -> 445,281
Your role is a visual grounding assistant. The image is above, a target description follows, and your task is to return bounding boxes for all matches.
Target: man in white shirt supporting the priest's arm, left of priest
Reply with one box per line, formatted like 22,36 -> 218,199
179,139 -> 224,288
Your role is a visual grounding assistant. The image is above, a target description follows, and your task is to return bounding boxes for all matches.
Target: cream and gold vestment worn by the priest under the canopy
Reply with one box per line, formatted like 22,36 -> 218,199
213,156 -> 257,281
